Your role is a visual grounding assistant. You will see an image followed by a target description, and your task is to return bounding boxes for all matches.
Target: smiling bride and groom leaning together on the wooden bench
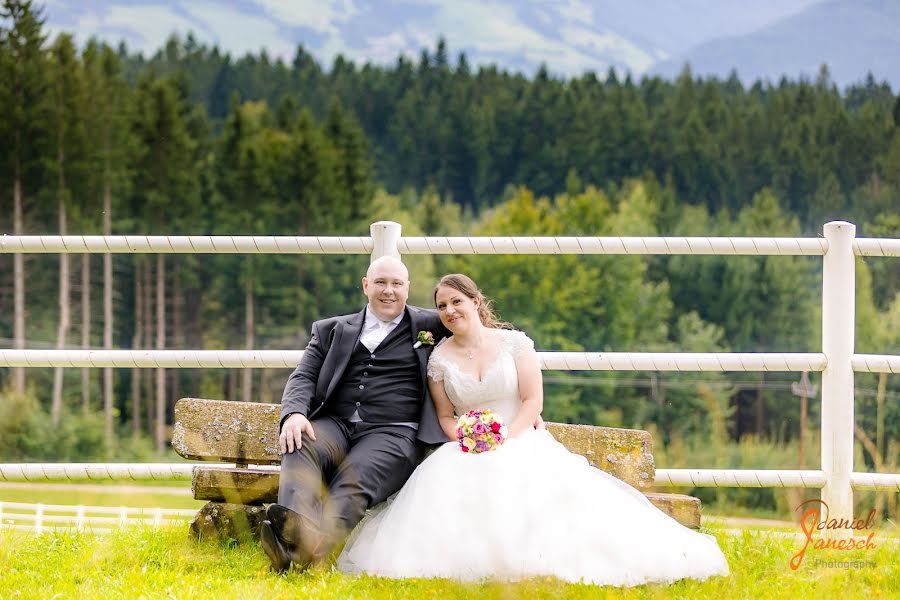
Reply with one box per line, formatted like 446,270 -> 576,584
260,257 -> 728,585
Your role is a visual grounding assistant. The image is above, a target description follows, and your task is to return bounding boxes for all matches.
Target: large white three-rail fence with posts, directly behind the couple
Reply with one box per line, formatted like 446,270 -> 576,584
0,221 -> 900,519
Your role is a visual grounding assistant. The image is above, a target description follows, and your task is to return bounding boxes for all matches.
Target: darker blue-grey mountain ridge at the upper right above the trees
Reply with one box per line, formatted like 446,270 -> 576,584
651,0 -> 900,88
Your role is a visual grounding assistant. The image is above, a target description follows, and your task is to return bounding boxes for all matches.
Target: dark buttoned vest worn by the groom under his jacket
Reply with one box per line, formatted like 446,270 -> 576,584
325,315 -> 424,423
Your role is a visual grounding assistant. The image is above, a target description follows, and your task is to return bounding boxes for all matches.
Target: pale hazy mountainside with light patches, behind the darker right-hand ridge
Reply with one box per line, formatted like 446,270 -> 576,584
39,0 -> 823,75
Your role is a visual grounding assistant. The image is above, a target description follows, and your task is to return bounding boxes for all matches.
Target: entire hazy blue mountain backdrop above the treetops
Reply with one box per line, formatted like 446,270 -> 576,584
38,0 -> 900,86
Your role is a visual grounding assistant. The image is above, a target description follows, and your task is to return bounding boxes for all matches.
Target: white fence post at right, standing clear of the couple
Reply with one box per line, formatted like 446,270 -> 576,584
822,221 -> 856,537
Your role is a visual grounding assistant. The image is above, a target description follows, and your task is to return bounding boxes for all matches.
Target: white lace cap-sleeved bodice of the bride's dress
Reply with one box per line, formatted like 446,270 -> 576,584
428,330 -> 534,424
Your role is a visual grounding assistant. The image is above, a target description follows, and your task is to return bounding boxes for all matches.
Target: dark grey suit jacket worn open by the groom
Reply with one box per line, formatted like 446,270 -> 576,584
281,305 -> 449,444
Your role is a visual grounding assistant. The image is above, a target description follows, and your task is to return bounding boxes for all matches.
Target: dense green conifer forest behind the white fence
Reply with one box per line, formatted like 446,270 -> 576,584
0,0 -> 900,508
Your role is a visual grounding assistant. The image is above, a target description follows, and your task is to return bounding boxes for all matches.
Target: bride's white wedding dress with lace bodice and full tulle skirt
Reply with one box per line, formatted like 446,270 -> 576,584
338,331 -> 728,586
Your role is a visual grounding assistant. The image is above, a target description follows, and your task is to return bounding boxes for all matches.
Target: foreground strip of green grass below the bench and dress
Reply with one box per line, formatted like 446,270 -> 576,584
0,526 -> 900,600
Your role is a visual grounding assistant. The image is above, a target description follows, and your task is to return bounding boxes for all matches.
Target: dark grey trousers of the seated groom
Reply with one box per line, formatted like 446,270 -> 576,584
278,416 -> 423,560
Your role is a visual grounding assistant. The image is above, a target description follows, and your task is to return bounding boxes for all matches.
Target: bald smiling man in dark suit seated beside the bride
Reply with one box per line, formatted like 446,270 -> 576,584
259,257 -> 449,571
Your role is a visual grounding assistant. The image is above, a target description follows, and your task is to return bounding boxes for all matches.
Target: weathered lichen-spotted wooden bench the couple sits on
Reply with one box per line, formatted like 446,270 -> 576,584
172,398 -> 700,540
